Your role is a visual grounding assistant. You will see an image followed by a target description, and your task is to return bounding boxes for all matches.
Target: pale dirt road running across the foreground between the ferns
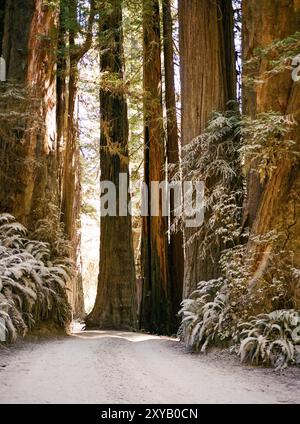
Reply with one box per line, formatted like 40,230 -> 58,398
0,331 -> 300,404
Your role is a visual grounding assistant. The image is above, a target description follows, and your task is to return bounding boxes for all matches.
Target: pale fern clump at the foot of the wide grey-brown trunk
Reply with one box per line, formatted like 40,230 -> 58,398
178,278 -> 229,352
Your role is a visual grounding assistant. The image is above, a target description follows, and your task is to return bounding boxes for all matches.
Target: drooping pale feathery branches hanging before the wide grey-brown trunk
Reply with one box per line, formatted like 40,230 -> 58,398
170,104 -> 244,252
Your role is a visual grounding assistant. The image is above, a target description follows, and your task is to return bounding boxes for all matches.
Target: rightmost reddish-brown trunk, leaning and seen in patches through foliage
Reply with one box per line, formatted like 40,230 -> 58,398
243,0 -> 300,312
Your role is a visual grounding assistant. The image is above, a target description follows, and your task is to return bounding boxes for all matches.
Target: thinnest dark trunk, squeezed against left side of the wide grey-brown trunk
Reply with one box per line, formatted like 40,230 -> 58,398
163,0 -> 184,328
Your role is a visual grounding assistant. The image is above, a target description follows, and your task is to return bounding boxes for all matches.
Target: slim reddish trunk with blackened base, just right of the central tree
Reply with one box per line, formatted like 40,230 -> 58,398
140,0 -> 170,334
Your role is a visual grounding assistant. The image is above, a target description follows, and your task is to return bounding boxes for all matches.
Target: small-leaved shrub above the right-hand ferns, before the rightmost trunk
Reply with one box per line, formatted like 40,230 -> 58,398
220,232 -> 300,320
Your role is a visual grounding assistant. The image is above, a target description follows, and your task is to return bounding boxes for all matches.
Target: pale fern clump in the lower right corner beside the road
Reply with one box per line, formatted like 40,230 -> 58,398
234,310 -> 300,370
